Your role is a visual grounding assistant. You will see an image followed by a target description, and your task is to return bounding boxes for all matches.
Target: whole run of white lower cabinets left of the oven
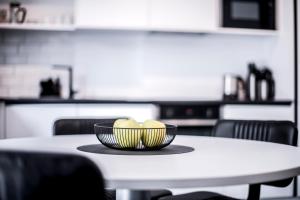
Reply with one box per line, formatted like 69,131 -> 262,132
4,104 -> 158,138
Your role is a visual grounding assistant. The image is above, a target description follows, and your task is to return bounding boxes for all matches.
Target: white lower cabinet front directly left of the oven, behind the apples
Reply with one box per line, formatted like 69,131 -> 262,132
78,104 -> 158,122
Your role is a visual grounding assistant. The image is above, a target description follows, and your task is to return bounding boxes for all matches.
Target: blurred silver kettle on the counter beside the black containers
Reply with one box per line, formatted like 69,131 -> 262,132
223,74 -> 246,101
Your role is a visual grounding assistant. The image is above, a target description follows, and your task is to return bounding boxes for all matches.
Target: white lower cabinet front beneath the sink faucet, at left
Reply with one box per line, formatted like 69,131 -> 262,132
6,104 -> 76,138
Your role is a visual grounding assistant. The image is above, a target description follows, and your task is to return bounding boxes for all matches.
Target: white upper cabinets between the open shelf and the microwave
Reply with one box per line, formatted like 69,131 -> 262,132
75,0 -> 220,32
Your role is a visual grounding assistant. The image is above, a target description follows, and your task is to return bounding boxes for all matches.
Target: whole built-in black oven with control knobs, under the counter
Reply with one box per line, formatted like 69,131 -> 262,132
159,102 -> 220,136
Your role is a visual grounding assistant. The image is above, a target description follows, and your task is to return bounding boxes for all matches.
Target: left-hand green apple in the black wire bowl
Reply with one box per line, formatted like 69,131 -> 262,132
113,119 -> 143,148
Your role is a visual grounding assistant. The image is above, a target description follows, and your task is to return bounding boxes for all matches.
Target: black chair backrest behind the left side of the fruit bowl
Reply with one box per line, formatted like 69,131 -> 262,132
53,117 -> 124,135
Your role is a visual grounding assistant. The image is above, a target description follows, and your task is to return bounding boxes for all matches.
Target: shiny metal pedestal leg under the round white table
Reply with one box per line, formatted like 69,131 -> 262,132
116,189 -> 151,200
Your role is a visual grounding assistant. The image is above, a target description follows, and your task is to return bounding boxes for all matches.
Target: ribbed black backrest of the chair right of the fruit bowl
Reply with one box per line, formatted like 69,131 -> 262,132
213,120 -> 298,187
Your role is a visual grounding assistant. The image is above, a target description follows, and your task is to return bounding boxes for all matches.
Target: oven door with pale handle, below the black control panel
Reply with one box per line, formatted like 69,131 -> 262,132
161,119 -> 217,136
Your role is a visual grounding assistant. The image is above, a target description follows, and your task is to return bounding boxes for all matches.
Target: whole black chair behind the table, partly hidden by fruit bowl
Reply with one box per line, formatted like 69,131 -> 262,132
53,117 -> 172,200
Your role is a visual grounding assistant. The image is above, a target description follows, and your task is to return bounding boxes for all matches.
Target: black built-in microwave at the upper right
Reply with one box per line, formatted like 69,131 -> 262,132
222,0 -> 276,30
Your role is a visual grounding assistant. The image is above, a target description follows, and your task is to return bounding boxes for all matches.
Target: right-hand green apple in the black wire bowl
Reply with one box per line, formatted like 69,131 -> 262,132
142,120 -> 166,147
